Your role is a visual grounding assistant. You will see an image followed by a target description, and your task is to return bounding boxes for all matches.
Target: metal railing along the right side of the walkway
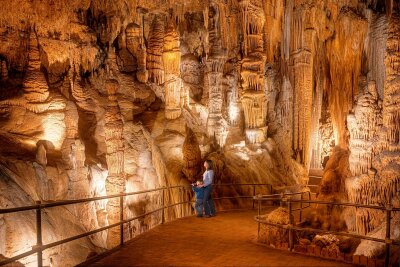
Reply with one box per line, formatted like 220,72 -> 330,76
254,195 -> 400,266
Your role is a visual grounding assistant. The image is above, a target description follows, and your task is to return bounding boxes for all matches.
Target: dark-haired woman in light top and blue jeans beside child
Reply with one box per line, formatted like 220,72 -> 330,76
202,160 -> 216,218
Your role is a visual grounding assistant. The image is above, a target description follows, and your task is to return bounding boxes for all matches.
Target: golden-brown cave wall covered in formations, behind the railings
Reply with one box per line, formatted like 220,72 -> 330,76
0,0 -> 400,265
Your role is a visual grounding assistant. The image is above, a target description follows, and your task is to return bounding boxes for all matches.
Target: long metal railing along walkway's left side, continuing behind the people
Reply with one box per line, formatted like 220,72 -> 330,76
0,184 -> 272,267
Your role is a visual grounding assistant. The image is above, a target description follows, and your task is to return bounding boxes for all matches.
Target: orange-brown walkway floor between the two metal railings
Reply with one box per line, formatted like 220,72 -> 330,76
86,210 -> 351,267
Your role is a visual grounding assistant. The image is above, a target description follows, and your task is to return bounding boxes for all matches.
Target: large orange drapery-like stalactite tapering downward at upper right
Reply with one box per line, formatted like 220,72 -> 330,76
327,9 -> 368,147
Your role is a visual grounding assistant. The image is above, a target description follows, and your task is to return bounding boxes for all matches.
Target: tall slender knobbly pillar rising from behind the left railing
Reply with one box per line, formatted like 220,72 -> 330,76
104,80 -> 125,248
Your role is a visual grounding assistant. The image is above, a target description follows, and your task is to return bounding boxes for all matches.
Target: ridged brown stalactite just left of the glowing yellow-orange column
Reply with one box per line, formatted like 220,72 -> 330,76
147,16 -> 164,84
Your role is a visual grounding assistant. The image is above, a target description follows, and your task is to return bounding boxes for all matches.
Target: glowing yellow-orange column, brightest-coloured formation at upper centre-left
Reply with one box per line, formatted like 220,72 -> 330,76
162,19 -> 183,120
